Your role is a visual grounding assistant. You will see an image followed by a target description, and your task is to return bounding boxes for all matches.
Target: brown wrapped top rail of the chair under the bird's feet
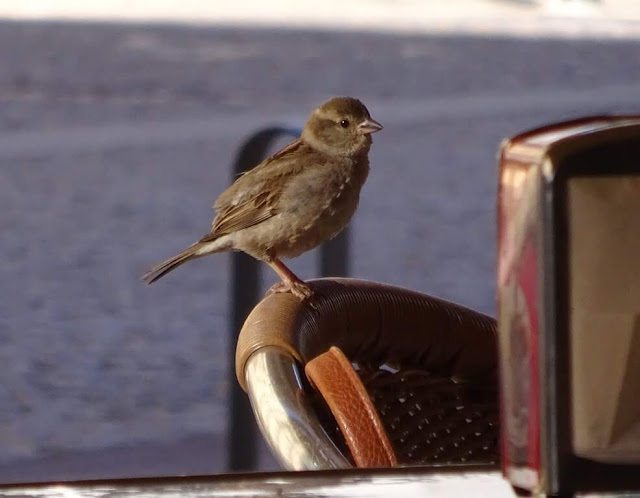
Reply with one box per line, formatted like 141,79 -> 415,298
236,278 -> 497,390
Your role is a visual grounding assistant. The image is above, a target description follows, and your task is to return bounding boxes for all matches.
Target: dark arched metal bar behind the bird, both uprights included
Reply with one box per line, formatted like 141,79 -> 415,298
227,126 -> 349,471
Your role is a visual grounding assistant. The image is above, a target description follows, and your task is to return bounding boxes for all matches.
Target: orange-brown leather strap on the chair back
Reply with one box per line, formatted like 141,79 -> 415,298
305,346 -> 398,467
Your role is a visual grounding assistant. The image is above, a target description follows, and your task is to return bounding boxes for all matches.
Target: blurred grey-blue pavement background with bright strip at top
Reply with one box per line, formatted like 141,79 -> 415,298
0,0 -> 640,482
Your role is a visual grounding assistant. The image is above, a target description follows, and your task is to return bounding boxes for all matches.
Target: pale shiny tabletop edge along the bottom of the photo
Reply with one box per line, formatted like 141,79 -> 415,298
0,467 -> 515,498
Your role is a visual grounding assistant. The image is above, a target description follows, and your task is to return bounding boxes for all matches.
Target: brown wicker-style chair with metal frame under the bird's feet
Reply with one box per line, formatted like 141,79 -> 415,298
236,278 -> 499,470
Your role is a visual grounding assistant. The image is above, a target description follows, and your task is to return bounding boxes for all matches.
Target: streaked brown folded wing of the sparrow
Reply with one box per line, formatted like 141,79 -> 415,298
207,140 -> 306,238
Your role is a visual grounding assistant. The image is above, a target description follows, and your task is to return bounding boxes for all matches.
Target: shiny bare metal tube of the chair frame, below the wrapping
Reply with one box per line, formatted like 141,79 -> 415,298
245,346 -> 351,470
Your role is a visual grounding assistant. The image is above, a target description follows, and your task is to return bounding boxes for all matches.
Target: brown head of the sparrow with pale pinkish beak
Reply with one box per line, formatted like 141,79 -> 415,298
302,97 -> 382,156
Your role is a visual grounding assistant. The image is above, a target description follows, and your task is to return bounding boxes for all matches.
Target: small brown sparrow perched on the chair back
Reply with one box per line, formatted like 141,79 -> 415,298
142,97 -> 382,299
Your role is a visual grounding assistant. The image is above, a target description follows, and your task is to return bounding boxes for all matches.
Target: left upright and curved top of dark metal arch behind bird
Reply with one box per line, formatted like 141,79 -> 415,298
227,127 -> 300,472
